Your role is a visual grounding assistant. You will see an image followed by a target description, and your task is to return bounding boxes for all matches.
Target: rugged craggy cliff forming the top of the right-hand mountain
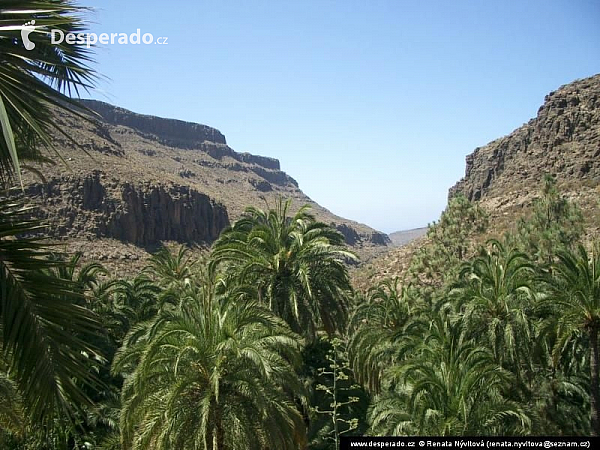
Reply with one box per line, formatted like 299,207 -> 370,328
449,75 -> 600,200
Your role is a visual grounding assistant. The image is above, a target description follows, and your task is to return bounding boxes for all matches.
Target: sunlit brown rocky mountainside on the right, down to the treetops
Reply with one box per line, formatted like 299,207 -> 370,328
354,74 -> 600,286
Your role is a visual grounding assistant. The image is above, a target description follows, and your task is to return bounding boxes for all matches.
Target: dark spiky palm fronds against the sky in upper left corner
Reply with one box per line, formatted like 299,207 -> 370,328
0,0 -> 96,184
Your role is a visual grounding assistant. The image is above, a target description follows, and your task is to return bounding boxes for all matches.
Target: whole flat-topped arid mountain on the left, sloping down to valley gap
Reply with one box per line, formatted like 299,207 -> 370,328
25,101 -> 390,270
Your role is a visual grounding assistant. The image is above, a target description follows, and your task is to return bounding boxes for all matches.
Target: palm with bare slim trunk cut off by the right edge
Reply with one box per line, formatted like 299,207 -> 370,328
540,244 -> 600,436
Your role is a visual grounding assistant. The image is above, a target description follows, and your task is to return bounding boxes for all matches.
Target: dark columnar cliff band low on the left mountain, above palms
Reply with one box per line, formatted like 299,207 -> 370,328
27,171 -> 229,246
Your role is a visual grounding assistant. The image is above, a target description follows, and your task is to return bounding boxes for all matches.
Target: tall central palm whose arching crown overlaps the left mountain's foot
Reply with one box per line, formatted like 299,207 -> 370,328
212,198 -> 356,340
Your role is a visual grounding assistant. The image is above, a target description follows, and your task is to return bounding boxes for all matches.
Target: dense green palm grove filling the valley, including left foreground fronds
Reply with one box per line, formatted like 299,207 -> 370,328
0,1 -> 600,450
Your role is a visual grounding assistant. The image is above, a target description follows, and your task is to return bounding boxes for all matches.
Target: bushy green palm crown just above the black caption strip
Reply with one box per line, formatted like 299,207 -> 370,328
370,314 -> 530,436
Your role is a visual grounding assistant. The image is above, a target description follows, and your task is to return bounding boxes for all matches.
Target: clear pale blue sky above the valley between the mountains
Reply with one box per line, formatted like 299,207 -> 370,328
80,0 -> 600,232
